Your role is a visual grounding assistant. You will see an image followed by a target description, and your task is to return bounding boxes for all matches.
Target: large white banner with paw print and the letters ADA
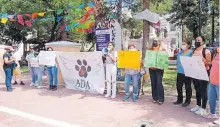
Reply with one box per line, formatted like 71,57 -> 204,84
56,51 -> 105,94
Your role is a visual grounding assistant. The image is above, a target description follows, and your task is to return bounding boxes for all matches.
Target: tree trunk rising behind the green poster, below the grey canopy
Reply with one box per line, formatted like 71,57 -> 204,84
142,0 -> 150,60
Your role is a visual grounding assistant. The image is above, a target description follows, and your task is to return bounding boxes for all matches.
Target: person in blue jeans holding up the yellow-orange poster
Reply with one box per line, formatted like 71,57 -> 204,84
123,44 -> 140,102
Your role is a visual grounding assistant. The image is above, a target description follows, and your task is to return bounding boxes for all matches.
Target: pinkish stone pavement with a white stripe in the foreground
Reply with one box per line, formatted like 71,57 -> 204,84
0,76 -> 218,127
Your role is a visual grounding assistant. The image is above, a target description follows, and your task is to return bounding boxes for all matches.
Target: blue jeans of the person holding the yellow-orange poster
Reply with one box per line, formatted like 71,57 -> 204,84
125,74 -> 139,95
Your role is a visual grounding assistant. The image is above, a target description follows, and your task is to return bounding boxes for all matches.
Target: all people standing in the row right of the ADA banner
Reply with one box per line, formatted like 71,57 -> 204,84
104,36 -> 220,124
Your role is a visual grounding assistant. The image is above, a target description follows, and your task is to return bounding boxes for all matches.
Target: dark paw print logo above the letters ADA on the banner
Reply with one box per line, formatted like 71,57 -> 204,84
75,60 -> 91,78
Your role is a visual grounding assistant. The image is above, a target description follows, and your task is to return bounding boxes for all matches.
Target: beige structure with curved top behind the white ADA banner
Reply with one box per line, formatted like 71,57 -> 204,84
45,41 -> 81,86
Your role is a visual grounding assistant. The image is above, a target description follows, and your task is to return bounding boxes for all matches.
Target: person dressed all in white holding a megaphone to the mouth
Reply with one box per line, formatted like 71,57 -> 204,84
105,42 -> 117,98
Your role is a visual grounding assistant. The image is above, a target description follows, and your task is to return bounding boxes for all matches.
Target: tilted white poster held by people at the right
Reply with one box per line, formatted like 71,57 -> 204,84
180,56 -> 209,81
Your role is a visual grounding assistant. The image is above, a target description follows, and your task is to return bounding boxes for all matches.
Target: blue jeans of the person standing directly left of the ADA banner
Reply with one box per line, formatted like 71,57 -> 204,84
47,66 -> 58,86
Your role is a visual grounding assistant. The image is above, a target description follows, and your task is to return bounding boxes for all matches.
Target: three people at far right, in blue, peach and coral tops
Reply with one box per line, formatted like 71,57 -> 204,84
174,36 -> 220,124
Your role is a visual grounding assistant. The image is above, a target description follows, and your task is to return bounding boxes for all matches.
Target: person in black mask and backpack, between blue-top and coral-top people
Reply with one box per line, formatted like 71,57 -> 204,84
190,36 -> 211,116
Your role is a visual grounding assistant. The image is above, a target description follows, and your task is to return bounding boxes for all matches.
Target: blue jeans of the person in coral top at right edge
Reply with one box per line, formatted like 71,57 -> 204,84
208,83 -> 220,114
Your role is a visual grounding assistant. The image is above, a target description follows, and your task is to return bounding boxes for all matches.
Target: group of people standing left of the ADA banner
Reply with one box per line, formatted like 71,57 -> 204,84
3,46 -> 58,92
